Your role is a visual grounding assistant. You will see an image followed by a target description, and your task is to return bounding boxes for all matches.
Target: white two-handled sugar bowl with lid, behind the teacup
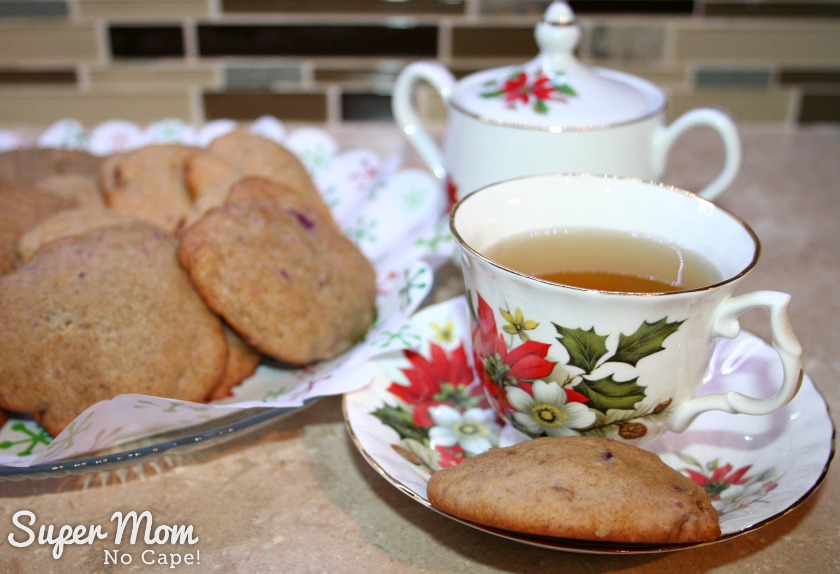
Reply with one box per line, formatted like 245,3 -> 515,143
392,2 -> 742,201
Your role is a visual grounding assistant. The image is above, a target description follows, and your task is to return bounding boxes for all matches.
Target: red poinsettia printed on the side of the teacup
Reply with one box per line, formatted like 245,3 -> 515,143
472,295 -> 560,405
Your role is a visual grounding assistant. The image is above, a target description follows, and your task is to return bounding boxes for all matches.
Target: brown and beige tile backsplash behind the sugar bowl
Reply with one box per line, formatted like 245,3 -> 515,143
0,0 -> 840,126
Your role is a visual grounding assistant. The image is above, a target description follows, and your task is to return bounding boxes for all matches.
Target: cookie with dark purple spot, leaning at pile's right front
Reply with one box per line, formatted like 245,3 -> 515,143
178,177 -> 376,365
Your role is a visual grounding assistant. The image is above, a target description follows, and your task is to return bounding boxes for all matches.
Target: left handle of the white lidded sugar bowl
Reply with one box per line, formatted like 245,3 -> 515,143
391,62 -> 455,181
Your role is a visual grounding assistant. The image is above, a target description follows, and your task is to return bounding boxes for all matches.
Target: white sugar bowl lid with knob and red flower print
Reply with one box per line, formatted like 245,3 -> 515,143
450,2 -> 665,131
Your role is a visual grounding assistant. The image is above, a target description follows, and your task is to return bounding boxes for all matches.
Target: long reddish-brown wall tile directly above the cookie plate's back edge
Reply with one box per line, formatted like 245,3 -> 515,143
202,91 -> 327,122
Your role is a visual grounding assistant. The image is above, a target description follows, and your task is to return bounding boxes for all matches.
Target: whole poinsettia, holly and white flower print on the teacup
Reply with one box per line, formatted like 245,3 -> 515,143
470,293 -> 682,439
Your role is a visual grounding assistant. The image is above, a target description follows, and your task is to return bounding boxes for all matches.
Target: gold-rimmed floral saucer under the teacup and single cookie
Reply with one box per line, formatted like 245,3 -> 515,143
343,297 -> 834,554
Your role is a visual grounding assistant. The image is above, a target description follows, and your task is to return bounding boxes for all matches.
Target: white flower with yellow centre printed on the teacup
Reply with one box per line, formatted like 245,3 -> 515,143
505,381 -> 595,436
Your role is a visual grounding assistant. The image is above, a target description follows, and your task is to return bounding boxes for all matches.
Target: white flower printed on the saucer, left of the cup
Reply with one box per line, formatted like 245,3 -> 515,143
429,405 -> 500,454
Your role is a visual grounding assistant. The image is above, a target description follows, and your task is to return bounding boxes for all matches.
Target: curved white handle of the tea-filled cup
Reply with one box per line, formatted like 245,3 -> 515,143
670,291 -> 804,432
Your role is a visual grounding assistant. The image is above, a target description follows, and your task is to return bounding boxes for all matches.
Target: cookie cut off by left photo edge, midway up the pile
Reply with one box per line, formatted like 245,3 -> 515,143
0,186 -> 77,275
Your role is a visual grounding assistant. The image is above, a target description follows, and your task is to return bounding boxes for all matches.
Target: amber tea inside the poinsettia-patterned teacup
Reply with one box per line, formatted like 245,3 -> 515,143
486,228 -> 720,293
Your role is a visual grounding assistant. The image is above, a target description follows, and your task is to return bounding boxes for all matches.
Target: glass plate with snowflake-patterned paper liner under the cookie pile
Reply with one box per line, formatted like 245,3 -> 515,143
0,117 -> 453,480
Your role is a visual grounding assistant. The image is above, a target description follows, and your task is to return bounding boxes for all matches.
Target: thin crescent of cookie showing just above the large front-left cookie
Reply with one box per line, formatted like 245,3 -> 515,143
16,206 -> 138,263
